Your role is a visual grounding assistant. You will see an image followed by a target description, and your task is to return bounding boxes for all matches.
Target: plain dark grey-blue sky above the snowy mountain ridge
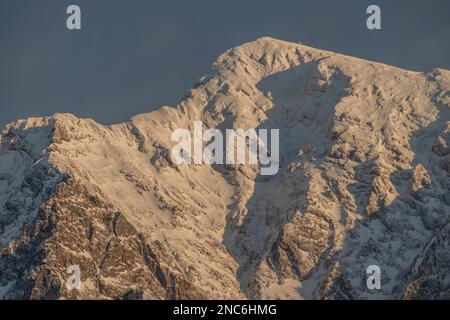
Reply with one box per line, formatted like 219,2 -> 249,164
0,0 -> 450,127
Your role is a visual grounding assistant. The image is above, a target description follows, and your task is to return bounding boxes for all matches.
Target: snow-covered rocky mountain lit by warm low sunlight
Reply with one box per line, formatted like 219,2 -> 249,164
0,38 -> 450,299
